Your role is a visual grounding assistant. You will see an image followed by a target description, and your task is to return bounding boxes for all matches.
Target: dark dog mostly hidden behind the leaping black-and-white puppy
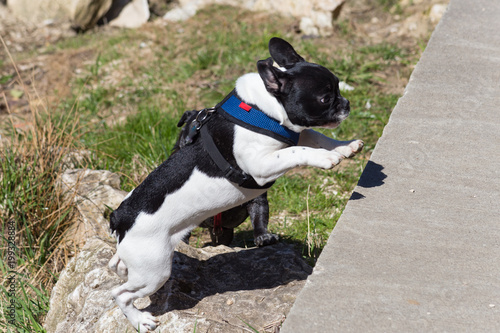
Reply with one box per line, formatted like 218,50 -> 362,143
172,110 -> 279,247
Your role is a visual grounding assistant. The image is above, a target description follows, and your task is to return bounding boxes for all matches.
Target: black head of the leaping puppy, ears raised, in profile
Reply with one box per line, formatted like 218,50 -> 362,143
257,38 -> 350,128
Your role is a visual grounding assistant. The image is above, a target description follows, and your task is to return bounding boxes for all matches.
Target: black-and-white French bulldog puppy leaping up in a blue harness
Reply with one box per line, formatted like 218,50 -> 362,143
109,38 -> 363,332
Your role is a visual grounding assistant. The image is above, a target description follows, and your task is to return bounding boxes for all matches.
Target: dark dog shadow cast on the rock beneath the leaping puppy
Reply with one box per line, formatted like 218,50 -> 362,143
145,243 -> 312,316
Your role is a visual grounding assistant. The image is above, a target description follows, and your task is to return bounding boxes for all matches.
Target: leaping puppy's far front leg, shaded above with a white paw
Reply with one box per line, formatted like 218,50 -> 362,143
298,129 -> 364,157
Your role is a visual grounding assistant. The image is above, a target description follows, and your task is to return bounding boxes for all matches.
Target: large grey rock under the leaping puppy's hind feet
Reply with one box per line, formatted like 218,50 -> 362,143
44,170 -> 312,333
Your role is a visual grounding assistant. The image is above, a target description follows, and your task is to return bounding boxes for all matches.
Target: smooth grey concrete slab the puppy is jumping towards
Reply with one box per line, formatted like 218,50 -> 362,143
281,0 -> 500,333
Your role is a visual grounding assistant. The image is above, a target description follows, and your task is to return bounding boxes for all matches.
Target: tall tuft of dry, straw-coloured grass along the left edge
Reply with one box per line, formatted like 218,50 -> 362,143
0,35 -> 83,332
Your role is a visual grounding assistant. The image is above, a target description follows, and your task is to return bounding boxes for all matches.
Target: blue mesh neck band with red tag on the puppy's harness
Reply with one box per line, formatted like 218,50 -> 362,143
216,90 -> 300,146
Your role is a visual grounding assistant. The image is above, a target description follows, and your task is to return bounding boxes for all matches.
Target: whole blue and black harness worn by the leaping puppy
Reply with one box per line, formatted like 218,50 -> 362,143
180,90 -> 299,189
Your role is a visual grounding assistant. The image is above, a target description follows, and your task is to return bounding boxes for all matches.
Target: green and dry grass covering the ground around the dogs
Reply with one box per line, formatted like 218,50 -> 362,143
0,0 -> 423,332
